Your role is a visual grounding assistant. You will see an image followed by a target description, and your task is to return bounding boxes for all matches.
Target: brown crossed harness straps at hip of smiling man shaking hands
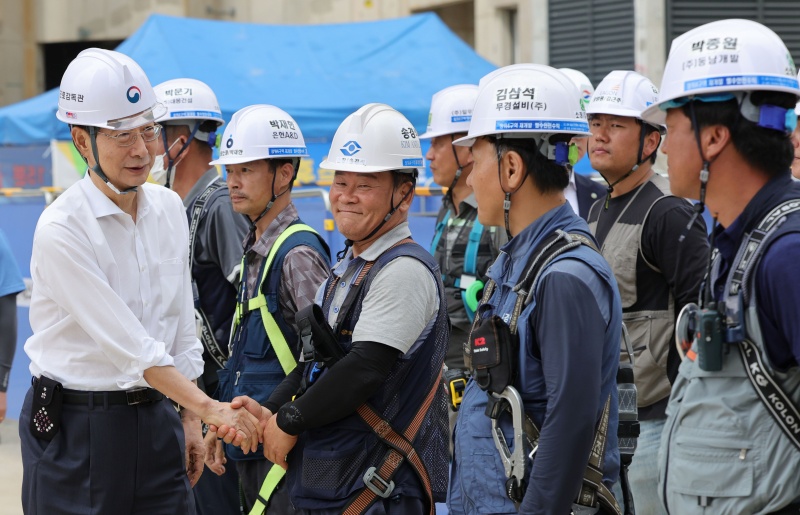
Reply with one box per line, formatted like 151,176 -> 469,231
343,370 -> 442,515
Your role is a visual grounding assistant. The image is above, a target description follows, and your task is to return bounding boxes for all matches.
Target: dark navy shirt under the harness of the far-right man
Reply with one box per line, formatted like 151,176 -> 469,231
714,173 -> 800,371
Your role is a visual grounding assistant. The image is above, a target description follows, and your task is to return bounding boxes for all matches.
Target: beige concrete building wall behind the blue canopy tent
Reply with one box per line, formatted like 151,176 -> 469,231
0,0 -> 667,105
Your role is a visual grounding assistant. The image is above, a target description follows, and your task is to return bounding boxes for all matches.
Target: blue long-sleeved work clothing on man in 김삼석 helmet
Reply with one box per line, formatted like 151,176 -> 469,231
448,204 -> 622,514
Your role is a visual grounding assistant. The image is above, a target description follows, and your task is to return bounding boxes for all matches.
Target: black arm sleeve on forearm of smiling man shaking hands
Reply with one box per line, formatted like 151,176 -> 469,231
270,342 -> 400,435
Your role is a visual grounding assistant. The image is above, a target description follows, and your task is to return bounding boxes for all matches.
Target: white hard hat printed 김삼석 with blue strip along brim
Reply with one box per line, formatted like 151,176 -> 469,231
454,64 -> 589,146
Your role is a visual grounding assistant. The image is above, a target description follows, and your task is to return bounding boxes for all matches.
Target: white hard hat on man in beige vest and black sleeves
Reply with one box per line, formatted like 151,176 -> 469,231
586,70 -> 658,124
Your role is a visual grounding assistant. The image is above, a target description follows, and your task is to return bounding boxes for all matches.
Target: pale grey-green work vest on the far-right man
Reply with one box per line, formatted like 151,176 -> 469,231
658,206 -> 800,515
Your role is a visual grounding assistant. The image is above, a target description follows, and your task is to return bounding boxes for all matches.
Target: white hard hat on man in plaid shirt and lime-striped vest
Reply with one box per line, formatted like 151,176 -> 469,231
210,104 -> 308,165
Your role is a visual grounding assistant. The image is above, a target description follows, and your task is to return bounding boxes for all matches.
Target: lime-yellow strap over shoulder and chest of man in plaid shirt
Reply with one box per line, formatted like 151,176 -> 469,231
231,224 -> 317,375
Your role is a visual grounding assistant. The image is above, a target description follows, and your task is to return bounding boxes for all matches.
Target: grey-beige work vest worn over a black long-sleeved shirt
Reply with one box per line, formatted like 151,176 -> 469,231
589,174 -> 675,407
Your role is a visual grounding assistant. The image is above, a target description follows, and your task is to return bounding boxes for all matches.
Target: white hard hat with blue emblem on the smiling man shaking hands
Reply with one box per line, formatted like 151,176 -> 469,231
320,104 -> 425,173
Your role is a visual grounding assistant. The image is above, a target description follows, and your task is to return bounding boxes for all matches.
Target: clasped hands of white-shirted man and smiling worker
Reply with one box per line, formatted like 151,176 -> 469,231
204,396 -> 297,475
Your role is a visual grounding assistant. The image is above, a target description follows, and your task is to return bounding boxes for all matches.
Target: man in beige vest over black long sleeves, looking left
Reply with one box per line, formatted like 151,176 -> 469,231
587,70 -> 708,515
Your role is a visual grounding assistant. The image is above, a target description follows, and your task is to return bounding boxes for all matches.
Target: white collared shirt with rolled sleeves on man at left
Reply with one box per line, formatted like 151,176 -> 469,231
25,173 -> 203,390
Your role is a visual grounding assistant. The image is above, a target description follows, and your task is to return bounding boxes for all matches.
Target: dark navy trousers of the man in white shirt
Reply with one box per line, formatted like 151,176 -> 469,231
19,389 -> 195,515
